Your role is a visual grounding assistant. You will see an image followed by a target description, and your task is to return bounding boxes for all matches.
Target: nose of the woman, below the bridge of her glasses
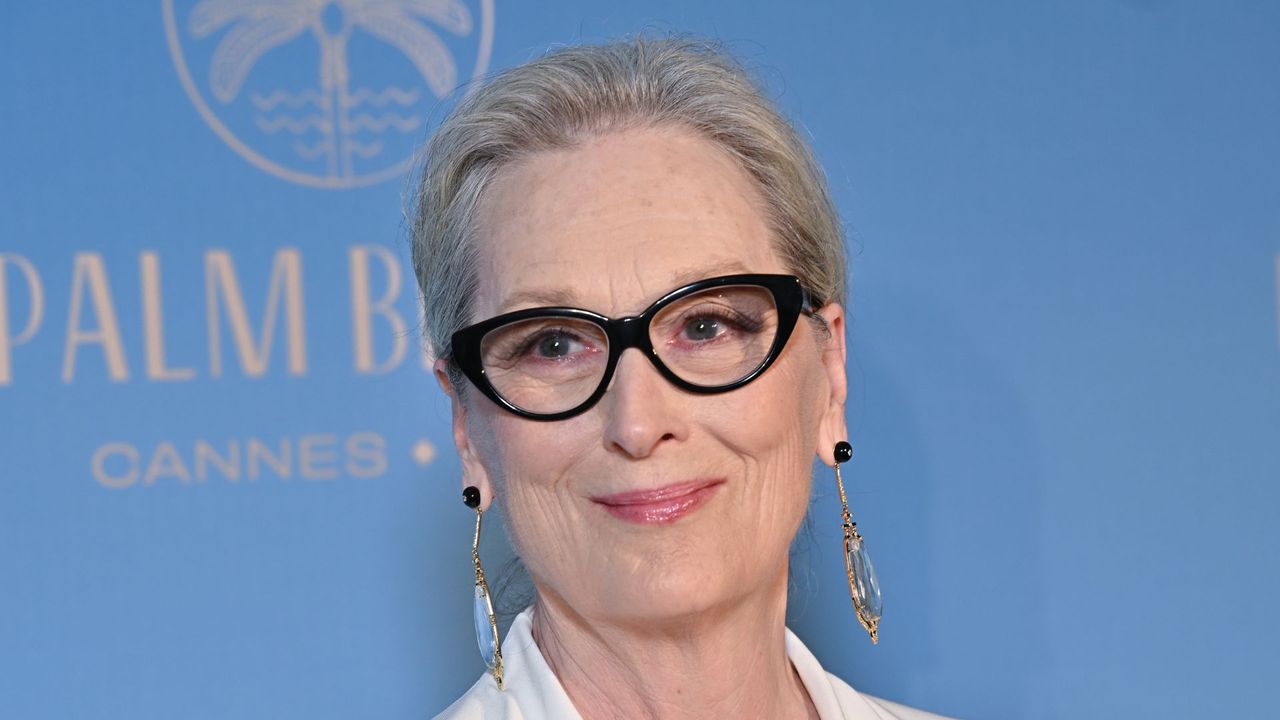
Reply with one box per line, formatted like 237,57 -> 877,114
600,348 -> 689,457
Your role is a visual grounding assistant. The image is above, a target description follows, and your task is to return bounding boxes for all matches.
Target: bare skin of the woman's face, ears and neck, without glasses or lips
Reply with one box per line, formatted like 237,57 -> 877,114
436,128 -> 846,719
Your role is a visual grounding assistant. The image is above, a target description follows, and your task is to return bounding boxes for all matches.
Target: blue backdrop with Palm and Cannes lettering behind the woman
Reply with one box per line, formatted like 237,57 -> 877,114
0,0 -> 1280,720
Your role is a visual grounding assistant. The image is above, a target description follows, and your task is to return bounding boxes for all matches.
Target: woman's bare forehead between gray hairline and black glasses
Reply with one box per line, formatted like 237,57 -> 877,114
474,128 -> 785,319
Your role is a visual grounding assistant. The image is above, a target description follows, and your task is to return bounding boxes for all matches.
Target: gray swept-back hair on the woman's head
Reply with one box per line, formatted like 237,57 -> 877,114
410,36 -> 847,389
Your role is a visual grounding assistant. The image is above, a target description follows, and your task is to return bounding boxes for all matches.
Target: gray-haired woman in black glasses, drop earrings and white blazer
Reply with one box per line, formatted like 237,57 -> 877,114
412,38 -> 952,720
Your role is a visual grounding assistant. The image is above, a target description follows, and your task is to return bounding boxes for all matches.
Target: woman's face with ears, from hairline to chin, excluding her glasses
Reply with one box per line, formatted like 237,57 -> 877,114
438,122 -> 845,623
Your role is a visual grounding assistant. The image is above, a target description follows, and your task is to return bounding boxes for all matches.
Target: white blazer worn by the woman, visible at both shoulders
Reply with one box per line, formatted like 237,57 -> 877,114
435,609 -> 947,720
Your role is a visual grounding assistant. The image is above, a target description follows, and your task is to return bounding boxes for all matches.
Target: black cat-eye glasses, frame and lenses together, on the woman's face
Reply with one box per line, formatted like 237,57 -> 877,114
452,274 -> 814,420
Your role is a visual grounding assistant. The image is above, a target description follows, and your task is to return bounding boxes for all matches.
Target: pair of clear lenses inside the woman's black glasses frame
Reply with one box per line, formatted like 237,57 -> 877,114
480,286 -> 778,414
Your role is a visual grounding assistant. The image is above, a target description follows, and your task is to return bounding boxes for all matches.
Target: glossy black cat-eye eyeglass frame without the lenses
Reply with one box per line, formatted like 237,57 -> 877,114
449,273 -> 817,421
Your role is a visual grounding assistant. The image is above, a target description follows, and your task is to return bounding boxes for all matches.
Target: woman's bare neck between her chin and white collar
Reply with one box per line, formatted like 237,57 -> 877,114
532,570 -> 818,720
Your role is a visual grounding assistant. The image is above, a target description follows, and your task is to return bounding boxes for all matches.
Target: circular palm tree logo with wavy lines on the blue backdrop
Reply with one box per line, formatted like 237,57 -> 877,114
163,0 -> 493,188
